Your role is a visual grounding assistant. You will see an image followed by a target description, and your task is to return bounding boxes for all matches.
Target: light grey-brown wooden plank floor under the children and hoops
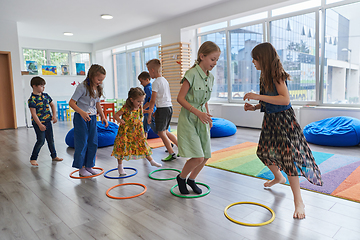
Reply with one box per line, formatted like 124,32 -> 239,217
0,122 -> 360,240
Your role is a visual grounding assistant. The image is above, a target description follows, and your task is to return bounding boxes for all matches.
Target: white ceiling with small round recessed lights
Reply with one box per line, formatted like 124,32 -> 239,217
0,0 -> 228,43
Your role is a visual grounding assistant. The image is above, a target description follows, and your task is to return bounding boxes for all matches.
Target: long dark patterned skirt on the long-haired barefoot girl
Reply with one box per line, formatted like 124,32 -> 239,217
256,108 -> 323,186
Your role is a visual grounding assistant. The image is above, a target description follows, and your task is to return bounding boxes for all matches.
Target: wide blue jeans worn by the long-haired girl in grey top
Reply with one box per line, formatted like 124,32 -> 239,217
72,112 -> 98,169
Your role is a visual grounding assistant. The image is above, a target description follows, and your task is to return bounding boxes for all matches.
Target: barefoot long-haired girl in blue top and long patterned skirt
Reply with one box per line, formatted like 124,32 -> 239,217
244,43 -> 322,219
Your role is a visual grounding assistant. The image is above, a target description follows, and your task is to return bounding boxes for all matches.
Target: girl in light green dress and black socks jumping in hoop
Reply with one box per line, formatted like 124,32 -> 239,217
176,41 -> 221,194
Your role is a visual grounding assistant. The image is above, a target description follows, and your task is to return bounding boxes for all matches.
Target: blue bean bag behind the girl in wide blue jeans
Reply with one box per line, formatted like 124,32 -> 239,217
65,121 -> 119,148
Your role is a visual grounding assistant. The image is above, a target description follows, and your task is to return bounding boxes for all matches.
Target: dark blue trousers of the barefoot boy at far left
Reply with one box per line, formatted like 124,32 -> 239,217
30,121 -> 56,160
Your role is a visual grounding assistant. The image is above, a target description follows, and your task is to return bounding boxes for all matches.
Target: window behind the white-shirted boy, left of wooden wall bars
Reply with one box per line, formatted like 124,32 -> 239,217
112,38 -> 161,99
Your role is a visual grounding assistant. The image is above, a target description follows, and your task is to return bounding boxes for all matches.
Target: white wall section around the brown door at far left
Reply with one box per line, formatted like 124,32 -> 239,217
0,20 -> 25,127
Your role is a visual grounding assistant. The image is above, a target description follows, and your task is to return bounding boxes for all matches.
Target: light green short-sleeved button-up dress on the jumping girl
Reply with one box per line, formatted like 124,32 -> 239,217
177,64 -> 214,158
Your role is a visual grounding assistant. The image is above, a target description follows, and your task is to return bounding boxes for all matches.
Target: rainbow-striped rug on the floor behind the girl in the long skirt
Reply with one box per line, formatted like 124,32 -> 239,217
206,142 -> 360,202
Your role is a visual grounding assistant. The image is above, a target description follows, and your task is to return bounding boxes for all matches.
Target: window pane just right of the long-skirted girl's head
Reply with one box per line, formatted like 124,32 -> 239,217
270,13 -> 316,101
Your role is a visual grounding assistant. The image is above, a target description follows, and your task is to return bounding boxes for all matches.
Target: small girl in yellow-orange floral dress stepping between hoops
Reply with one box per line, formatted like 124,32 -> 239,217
111,87 -> 162,176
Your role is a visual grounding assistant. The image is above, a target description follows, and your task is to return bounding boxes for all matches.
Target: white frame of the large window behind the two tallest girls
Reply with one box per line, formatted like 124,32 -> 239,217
194,0 -> 360,108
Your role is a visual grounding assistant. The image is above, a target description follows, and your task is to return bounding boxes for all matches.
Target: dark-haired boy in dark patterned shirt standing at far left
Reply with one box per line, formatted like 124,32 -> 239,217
28,76 -> 63,166
